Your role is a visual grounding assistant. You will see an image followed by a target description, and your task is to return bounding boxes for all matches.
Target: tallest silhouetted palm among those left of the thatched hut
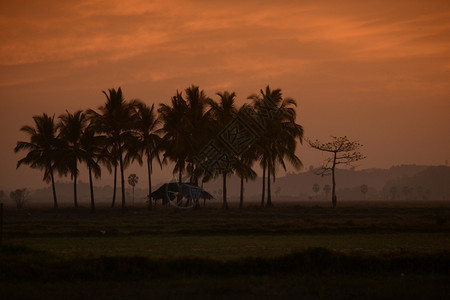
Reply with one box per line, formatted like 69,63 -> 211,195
88,87 -> 135,208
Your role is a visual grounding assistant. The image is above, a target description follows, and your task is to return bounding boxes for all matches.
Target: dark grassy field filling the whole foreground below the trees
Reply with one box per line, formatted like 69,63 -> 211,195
0,202 -> 450,299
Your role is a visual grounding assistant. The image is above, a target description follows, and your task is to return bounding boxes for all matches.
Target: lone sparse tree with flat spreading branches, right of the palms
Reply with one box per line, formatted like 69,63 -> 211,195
307,136 -> 366,207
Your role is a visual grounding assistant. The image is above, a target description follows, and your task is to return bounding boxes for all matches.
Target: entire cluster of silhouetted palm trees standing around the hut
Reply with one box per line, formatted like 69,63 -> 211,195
14,85 -> 303,210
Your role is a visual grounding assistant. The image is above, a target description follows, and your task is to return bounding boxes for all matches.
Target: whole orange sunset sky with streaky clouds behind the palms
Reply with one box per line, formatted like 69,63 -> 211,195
0,0 -> 450,190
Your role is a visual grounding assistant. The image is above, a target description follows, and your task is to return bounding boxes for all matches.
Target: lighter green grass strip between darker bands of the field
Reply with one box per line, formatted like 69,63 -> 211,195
9,232 -> 450,260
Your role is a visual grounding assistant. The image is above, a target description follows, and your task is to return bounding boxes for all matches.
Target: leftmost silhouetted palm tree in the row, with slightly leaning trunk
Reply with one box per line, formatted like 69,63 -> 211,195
14,113 -> 62,208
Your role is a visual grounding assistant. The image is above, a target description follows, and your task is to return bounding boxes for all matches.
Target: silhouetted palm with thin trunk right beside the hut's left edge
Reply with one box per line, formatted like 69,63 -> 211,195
133,102 -> 162,209
